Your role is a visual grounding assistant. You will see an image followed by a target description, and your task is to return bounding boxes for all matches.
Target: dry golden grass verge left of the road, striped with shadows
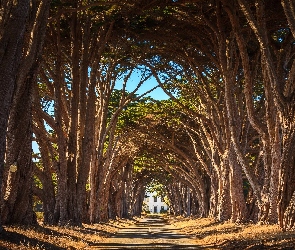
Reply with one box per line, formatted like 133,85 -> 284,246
0,219 -> 135,250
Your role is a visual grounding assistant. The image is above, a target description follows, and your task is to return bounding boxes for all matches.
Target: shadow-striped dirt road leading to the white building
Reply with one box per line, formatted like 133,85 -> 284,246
89,216 -> 201,249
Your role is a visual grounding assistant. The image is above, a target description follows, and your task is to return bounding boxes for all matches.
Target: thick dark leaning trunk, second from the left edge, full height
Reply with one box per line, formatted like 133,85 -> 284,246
0,0 -> 50,224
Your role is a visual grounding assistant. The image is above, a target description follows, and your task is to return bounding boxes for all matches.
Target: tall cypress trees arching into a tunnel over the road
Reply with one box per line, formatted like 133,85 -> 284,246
0,0 -> 295,230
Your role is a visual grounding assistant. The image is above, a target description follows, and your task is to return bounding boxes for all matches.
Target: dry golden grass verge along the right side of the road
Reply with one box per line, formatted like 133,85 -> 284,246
170,217 -> 295,249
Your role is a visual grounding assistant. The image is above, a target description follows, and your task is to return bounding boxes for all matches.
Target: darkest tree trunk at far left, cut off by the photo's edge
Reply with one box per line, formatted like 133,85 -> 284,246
0,0 -> 30,231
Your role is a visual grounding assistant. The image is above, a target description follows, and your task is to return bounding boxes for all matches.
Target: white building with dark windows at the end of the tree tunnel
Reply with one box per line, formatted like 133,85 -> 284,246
144,192 -> 168,214
